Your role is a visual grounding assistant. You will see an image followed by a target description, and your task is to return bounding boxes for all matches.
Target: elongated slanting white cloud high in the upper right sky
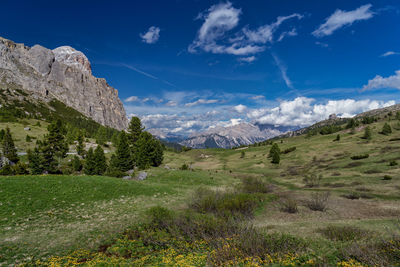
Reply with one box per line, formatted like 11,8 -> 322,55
312,4 -> 375,37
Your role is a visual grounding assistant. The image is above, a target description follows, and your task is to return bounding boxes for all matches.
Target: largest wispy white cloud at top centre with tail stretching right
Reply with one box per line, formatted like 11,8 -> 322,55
188,2 -> 303,56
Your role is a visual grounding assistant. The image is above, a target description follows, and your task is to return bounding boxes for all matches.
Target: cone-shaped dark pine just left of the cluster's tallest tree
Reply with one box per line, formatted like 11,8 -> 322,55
113,131 -> 133,172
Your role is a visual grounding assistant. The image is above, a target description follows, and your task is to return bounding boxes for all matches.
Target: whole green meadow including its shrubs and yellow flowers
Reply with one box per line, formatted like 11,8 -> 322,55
0,119 -> 400,266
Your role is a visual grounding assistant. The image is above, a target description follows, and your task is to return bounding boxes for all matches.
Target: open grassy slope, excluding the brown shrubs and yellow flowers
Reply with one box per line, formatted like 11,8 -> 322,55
0,118 -> 400,262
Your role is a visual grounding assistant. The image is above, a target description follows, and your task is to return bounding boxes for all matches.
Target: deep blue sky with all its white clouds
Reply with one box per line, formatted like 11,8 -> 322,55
0,0 -> 400,136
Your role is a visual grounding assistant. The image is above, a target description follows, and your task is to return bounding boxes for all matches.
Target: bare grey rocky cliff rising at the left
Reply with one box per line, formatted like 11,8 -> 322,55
0,37 -> 128,130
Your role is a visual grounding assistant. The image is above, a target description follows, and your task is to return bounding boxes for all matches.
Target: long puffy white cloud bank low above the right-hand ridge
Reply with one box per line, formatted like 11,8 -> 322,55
247,97 -> 395,127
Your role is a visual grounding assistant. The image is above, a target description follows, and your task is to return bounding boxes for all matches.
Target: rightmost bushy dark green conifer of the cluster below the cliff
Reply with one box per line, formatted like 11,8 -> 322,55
135,132 -> 163,169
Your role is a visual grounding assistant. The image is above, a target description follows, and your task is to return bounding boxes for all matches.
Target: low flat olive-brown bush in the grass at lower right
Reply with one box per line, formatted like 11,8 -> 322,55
319,225 -> 370,242
